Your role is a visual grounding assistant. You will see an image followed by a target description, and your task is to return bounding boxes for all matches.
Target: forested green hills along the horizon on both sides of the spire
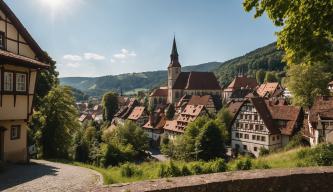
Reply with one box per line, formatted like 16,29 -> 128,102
60,43 -> 285,96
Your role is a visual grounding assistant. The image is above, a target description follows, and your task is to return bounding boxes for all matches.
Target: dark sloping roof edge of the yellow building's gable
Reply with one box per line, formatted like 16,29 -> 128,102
0,0 -> 47,61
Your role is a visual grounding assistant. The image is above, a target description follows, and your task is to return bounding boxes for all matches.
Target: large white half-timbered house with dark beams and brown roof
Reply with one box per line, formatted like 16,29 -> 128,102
229,97 -> 304,156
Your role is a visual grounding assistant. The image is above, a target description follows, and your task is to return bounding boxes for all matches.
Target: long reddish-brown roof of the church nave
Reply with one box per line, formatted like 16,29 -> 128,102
172,72 -> 221,90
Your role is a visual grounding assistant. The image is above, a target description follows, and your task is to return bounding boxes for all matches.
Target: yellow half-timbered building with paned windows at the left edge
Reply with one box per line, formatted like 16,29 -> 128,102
0,0 -> 49,162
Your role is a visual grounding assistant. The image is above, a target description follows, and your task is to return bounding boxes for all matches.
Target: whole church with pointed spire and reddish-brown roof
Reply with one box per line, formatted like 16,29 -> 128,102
150,38 -> 222,106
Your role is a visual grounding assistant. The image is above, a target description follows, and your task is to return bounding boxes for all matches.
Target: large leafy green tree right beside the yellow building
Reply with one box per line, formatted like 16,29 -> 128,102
32,86 -> 80,158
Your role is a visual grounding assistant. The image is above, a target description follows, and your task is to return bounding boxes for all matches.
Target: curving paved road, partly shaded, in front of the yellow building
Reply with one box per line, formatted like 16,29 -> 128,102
0,160 -> 101,192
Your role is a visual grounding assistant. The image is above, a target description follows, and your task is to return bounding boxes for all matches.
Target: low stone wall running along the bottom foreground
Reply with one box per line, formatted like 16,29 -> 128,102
97,167 -> 333,192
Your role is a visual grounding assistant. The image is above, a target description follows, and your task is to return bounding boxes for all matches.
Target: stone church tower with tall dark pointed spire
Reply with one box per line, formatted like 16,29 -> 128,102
168,37 -> 181,103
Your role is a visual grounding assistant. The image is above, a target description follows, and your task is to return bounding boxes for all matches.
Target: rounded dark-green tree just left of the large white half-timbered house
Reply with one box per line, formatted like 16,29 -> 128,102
196,120 -> 225,161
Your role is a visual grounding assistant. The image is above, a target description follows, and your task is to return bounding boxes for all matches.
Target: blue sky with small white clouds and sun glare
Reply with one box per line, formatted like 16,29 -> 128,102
5,0 -> 278,77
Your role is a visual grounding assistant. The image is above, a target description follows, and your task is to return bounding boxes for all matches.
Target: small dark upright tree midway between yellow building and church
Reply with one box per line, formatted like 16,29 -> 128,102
102,92 -> 118,121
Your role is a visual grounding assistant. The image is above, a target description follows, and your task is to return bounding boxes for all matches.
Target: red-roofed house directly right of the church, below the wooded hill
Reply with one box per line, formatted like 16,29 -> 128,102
222,74 -> 258,102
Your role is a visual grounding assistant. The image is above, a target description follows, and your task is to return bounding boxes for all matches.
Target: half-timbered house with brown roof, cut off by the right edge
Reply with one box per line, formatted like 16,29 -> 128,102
304,96 -> 333,146
